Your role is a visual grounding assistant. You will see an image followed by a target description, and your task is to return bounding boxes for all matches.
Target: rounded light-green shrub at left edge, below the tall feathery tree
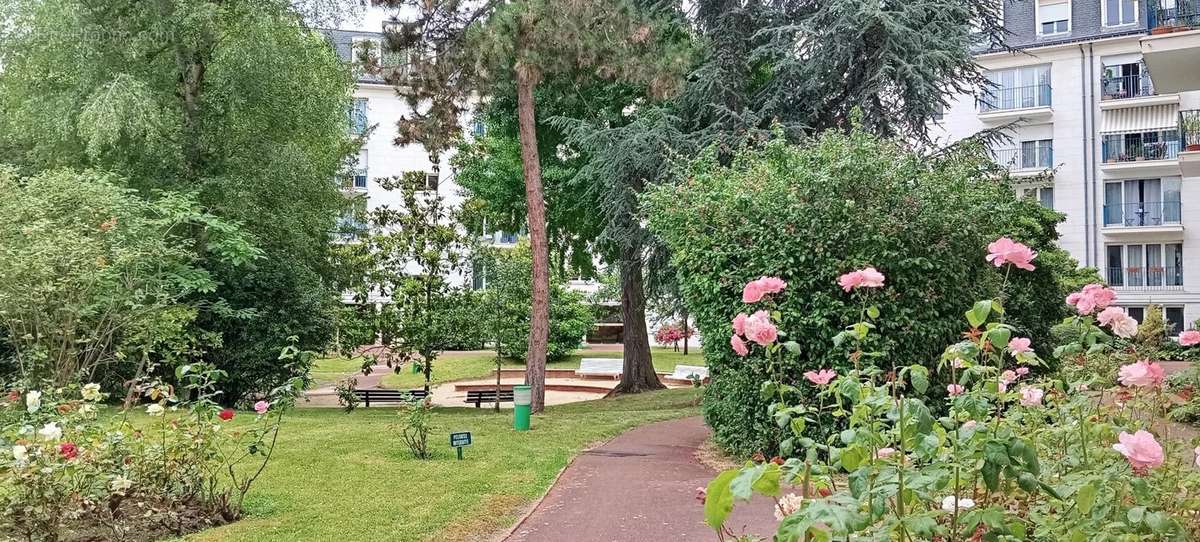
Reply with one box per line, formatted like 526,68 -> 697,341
0,168 -> 260,387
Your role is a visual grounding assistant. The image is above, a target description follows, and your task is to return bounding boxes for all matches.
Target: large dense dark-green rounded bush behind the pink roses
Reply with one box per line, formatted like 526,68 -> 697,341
646,132 -> 1094,454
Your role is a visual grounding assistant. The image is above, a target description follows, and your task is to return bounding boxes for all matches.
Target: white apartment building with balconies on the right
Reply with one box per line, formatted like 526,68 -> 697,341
934,0 -> 1200,333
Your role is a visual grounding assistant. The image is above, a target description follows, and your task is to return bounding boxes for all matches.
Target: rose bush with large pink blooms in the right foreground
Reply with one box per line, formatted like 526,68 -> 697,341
703,240 -> 1200,541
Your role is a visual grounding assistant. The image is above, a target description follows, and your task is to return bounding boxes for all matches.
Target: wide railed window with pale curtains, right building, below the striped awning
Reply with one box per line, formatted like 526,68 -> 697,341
1104,177 -> 1183,228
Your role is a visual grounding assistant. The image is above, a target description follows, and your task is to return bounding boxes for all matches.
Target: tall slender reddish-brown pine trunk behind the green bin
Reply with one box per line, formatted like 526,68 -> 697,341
516,66 -> 550,412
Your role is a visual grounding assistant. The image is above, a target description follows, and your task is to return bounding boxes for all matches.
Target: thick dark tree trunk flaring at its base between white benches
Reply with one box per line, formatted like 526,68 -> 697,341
610,240 -> 666,395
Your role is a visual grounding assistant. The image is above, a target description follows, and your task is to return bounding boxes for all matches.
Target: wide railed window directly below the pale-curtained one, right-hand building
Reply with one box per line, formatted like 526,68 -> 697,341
1105,243 -> 1183,288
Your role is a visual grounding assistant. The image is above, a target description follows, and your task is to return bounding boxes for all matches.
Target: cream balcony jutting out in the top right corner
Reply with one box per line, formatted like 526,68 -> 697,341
1141,0 -> 1200,92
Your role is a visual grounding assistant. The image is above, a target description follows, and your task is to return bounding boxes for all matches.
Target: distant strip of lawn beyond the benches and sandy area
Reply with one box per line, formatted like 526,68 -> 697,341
379,348 -> 704,389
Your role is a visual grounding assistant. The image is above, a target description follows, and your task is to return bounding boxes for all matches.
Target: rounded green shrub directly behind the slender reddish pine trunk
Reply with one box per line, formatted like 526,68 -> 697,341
482,242 -> 595,361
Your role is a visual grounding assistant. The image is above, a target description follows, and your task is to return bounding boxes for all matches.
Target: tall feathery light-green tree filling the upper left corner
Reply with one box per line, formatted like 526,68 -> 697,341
0,0 -> 354,401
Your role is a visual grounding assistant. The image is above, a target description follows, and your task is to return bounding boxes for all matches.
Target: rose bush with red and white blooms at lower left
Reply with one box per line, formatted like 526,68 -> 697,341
0,348 -> 302,541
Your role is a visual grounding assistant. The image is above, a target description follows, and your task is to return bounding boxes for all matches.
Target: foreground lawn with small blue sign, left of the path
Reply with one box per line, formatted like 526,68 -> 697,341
187,388 -> 700,542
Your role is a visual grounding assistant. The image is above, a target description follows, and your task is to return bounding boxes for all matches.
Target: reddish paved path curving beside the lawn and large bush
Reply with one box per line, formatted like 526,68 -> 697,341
505,417 -> 775,542
